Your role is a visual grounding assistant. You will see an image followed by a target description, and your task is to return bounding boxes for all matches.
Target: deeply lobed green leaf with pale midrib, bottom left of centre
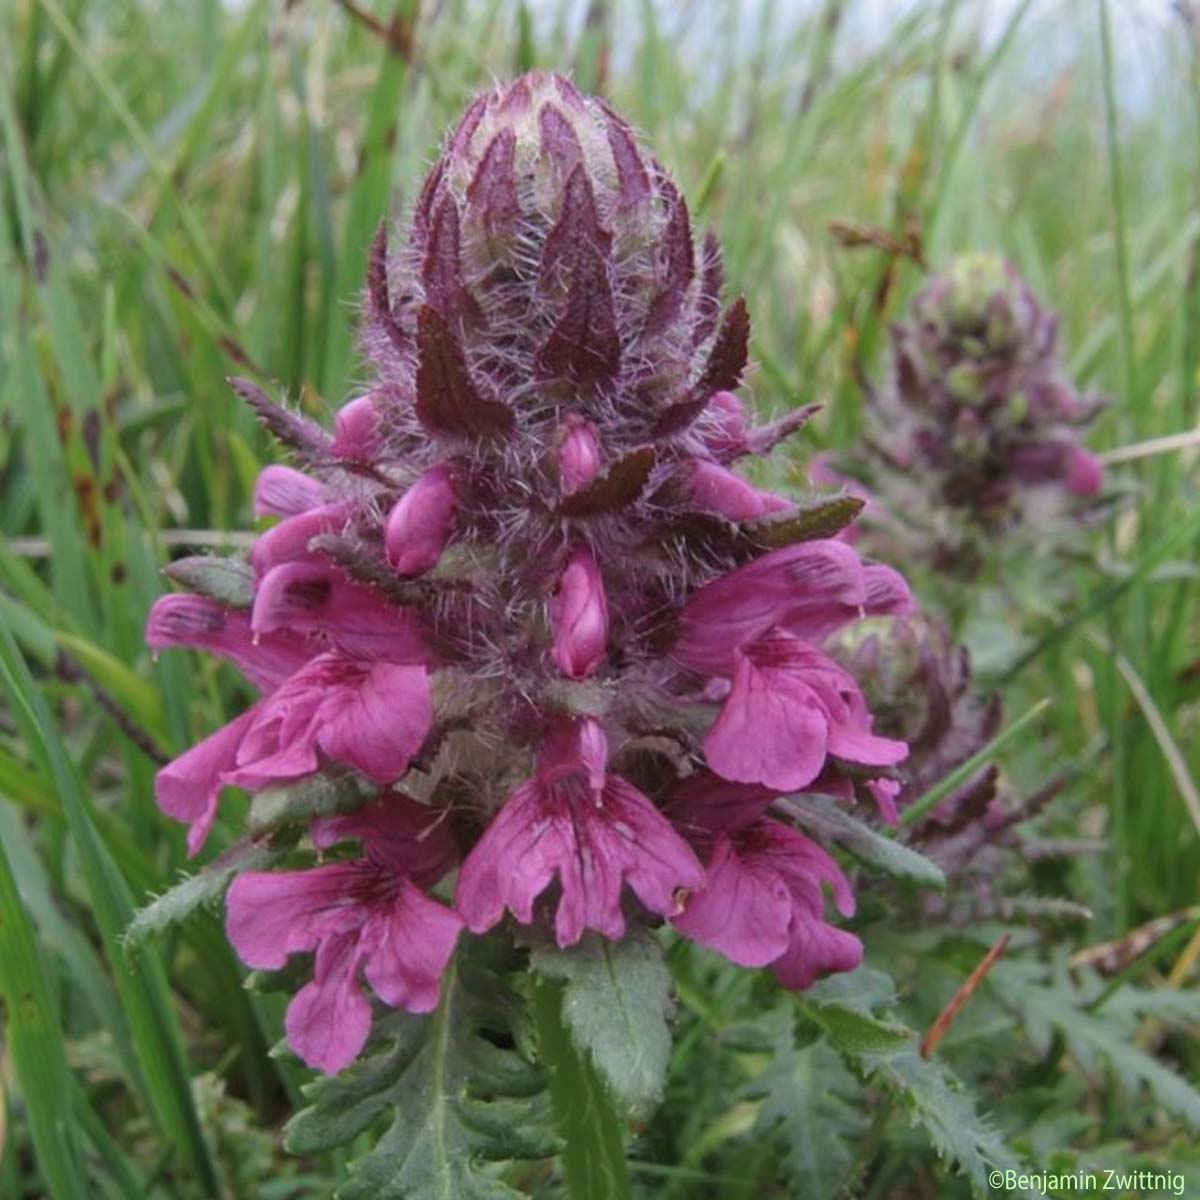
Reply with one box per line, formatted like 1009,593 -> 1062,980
286,950 -> 554,1200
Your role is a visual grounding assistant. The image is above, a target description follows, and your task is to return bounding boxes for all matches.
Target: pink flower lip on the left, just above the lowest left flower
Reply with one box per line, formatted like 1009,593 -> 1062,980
224,653 -> 433,791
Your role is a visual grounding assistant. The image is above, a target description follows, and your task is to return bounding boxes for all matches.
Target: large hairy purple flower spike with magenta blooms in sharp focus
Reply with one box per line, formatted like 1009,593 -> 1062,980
149,74 -> 912,1072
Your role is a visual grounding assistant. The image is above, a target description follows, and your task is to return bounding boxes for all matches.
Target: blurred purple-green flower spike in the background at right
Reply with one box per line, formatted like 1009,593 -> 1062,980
815,253 -> 1102,570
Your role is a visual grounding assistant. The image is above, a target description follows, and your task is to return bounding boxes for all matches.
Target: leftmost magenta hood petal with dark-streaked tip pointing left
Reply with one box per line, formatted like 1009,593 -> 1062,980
146,595 -> 312,691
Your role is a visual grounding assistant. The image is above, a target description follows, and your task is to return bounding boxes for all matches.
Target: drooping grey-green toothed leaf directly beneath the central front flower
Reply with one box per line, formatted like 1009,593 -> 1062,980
533,928 -> 672,1121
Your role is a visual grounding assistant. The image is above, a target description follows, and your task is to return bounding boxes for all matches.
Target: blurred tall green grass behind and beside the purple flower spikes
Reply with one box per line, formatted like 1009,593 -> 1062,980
0,0 -> 1200,1198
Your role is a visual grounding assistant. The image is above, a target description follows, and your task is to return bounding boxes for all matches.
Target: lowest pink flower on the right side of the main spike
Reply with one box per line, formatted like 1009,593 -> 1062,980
673,817 -> 863,990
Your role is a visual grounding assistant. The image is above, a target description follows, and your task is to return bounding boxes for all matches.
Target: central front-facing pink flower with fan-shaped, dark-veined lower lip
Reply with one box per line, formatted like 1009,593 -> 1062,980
455,719 -> 704,946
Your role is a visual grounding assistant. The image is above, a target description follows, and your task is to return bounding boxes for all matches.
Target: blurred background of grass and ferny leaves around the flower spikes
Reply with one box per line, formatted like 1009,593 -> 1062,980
0,0 -> 1200,1198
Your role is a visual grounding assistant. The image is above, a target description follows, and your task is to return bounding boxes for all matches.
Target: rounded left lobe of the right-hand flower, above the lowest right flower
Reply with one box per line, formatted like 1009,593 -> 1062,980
704,653 -> 829,792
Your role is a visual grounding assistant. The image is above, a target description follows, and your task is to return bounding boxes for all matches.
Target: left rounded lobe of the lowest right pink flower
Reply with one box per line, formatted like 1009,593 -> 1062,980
673,835 -> 792,967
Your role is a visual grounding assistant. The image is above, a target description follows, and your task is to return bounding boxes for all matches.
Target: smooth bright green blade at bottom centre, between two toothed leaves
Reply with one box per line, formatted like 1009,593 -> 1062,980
534,980 -> 630,1200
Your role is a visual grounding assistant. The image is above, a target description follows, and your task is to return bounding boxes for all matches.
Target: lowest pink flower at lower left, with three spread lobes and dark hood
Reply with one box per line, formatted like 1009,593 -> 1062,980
226,793 -> 462,1073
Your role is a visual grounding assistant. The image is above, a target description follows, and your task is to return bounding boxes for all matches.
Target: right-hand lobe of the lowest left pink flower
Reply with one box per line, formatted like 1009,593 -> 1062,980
364,880 -> 462,1013
